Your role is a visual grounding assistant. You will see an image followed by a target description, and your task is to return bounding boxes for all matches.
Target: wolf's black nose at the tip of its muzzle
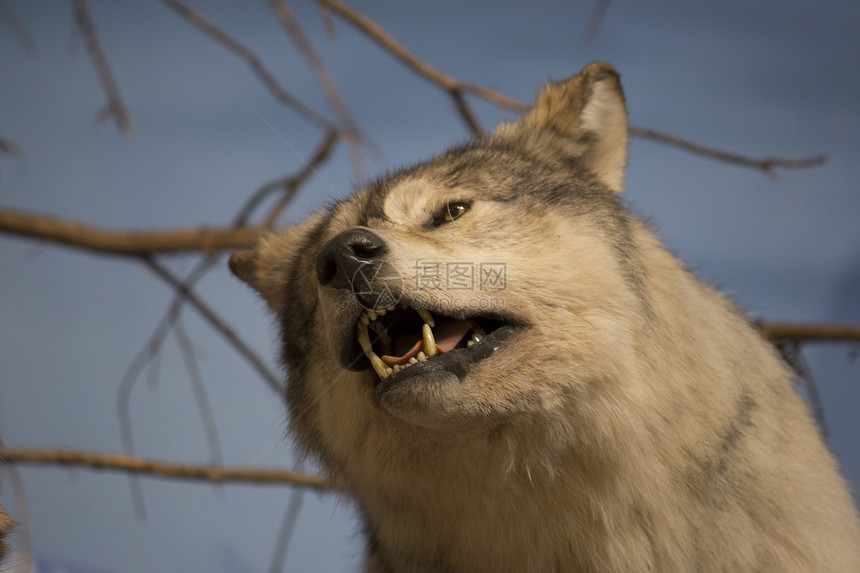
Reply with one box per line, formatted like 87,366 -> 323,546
316,227 -> 388,290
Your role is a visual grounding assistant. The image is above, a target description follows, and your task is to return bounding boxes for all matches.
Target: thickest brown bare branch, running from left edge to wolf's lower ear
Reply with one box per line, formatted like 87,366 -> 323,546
0,209 -> 264,256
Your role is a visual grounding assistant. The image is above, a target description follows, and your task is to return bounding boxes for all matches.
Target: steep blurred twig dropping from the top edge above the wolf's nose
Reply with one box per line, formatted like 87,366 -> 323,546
269,0 -> 365,180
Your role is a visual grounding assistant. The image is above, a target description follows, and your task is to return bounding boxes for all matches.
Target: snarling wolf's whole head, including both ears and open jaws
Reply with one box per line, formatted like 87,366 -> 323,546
230,63 -> 639,444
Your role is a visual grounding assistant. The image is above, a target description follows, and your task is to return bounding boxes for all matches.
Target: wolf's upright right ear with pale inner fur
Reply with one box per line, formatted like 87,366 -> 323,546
510,62 -> 627,191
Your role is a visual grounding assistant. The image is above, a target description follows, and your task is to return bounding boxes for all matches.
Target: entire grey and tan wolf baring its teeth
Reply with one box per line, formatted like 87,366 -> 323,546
230,63 -> 860,573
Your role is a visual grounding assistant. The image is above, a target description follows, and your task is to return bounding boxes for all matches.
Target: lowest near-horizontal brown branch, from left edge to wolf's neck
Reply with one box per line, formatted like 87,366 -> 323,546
0,448 -> 333,490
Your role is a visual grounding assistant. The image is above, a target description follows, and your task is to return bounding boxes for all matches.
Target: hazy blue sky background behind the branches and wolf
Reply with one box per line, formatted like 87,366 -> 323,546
0,0 -> 860,572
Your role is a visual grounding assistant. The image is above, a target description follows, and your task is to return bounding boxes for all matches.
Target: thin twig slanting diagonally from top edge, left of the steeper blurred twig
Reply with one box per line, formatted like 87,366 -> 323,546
162,0 -> 336,131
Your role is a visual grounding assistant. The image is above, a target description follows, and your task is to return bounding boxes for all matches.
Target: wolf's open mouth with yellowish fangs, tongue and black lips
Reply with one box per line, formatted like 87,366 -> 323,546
354,304 -> 516,381
